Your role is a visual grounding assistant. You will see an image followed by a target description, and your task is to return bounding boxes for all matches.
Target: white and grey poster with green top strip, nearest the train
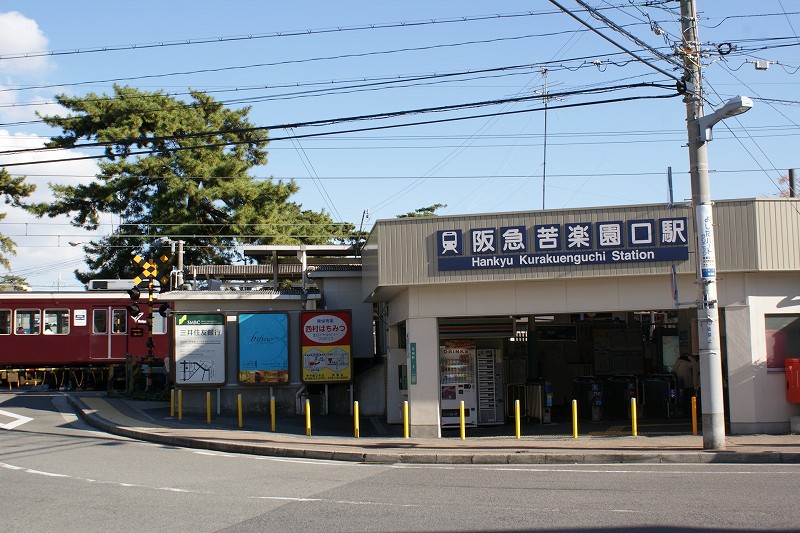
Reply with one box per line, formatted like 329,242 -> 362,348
174,313 -> 225,385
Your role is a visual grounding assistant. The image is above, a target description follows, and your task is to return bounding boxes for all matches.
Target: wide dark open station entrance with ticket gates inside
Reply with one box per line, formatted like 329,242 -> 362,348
428,309 -> 724,433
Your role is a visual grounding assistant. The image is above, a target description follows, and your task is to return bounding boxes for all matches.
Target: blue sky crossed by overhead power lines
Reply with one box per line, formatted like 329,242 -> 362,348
0,0 -> 800,291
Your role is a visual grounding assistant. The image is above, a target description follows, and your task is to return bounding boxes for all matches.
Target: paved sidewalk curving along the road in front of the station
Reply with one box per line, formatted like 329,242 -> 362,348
68,393 -> 800,464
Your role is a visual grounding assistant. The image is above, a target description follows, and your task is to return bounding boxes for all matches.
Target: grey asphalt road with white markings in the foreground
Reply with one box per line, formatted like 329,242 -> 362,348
0,392 -> 800,532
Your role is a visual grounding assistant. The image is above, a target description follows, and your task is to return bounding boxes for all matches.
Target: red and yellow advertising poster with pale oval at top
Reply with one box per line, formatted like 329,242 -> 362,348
300,311 -> 352,383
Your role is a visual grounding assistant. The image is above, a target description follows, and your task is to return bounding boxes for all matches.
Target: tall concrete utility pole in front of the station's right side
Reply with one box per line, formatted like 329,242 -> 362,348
681,0 -> 725,450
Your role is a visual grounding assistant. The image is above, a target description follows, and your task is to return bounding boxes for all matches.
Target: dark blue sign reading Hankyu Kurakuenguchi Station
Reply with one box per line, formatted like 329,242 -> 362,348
436,217 -> 689,271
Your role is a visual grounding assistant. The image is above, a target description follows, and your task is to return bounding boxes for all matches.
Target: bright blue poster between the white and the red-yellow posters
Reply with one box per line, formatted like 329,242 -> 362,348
238,313 -> 289,385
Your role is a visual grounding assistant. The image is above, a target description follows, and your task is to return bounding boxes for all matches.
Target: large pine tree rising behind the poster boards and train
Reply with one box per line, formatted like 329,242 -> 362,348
29,86 -> 354,282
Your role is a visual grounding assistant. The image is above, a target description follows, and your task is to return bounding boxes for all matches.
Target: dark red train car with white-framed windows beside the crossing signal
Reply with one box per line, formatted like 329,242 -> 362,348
0,291 -> 169,387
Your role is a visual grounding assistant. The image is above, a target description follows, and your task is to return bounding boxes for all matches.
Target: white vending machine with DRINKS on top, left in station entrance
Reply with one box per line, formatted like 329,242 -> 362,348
439,340 -> 478,427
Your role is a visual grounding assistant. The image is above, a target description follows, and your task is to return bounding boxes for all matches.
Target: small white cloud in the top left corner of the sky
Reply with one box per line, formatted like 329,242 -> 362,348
0,11 -> 50,75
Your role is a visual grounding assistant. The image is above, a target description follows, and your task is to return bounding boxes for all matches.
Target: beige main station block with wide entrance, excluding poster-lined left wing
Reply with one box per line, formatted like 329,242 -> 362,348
362,199 -> 800,437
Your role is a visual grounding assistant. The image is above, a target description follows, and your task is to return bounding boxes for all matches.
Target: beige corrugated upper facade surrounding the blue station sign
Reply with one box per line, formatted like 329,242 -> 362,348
364,198 -> 800,296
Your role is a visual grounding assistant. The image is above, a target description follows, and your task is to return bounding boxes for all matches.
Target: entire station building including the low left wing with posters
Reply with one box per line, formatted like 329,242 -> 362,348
161,198 -> 800,437
